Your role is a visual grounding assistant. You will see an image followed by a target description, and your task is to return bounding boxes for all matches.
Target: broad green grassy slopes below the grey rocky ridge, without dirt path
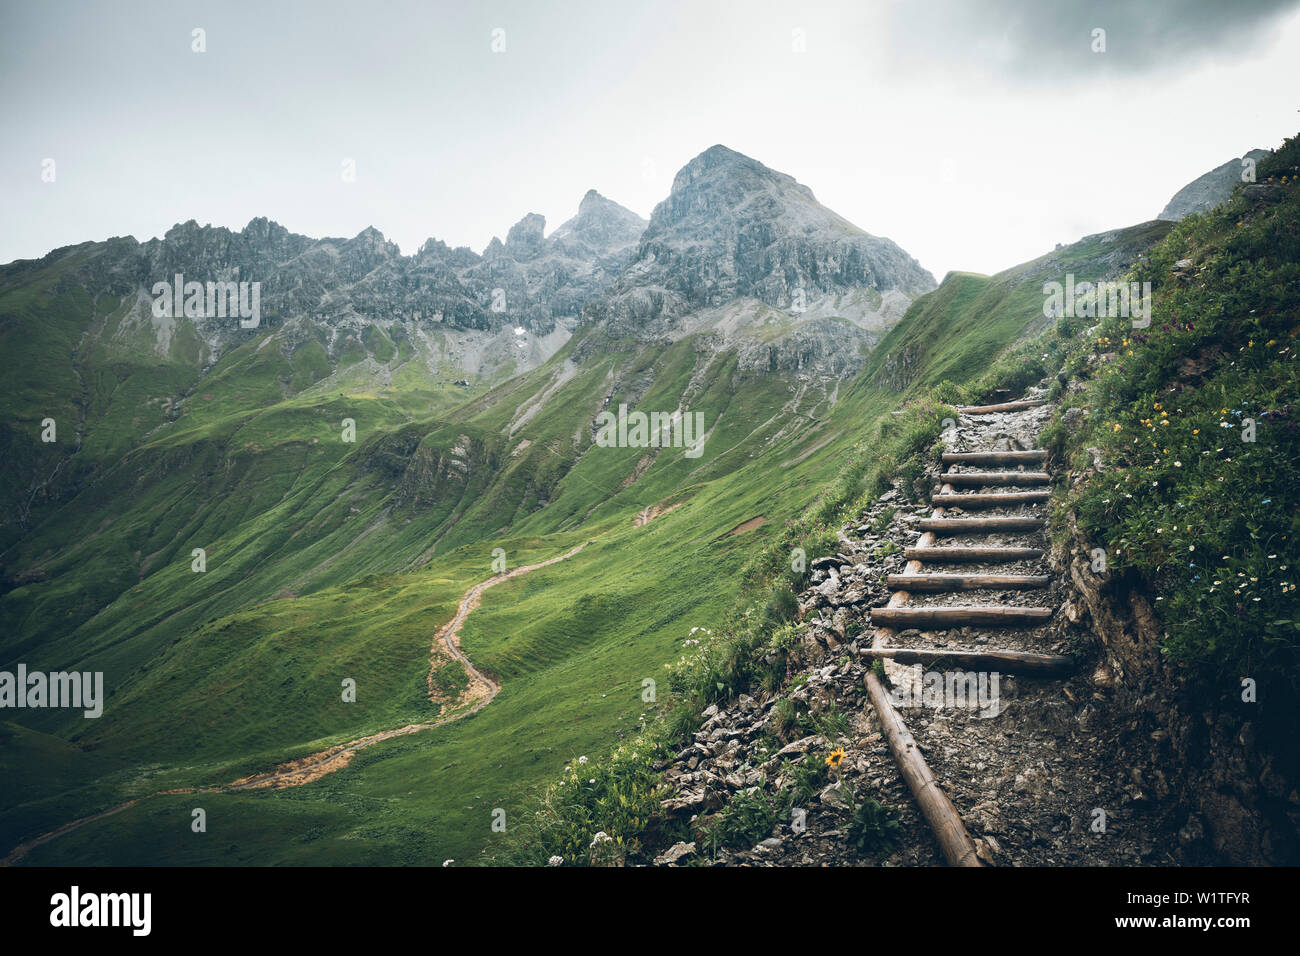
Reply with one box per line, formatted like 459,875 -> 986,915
0,214 -> 1170,864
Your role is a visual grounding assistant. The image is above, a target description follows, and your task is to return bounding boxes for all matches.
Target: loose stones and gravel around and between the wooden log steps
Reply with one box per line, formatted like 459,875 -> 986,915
657,394 -> 1203,866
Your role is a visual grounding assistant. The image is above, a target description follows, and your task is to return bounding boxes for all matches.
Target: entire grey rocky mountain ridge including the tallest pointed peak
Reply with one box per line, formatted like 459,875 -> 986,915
0,146 -> 935,385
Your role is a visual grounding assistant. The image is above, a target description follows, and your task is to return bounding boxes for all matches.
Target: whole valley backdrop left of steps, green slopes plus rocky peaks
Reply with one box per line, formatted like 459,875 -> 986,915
0,138 -> 1289,866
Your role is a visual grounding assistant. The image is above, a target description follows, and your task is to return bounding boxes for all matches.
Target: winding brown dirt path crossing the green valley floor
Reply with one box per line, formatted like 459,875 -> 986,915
0,542 -> 588,866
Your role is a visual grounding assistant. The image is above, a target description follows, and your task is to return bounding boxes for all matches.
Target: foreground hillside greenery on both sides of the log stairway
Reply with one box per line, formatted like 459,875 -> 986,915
506,139 -> 1300,865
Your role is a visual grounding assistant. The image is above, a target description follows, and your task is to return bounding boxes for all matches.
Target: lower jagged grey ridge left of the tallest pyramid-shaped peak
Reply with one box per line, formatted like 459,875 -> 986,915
16,190 -> 645,373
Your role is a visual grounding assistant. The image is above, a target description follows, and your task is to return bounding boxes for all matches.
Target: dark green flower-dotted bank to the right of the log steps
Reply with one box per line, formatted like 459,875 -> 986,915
1052,138 -> 1300,754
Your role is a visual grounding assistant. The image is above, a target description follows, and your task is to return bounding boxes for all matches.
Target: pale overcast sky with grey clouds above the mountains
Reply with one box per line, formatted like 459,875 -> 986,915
0,0 -> 1300,278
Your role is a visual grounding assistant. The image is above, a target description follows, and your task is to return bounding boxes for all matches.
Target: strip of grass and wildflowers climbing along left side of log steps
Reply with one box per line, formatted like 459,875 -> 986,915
495,234 -> 1190,865
